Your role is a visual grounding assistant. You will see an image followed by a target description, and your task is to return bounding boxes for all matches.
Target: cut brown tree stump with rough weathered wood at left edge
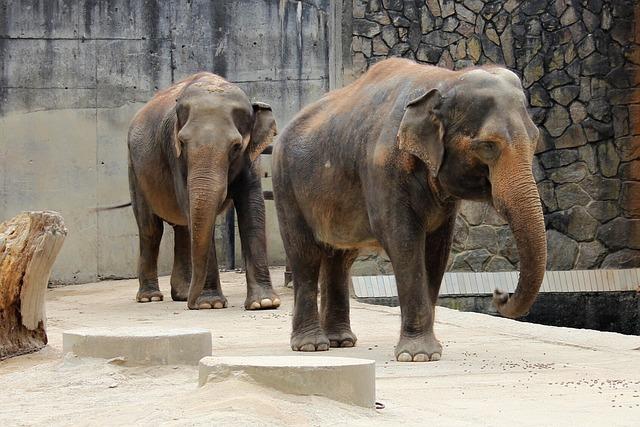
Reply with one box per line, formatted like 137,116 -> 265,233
0,211 -> 67,360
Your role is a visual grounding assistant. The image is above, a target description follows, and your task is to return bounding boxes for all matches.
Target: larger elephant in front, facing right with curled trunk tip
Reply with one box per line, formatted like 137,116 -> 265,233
272,58 -> 547,362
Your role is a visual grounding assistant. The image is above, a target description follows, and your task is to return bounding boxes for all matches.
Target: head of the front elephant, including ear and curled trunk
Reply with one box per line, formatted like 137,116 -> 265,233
397,67 -> 547,317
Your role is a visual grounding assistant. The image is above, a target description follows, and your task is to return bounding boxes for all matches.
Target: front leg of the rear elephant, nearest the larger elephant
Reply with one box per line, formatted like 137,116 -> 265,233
233,169 -> 280,310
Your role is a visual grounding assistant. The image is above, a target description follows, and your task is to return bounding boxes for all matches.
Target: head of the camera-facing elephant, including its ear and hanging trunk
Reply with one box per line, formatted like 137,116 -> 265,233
172,78 -> 277,307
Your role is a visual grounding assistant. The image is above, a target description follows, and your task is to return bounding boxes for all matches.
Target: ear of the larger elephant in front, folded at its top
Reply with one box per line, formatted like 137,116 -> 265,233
396,89 -> 444,177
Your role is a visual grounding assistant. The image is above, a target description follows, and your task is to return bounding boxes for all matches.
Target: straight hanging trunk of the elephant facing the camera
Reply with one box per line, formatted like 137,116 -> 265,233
187,156 -> 227,309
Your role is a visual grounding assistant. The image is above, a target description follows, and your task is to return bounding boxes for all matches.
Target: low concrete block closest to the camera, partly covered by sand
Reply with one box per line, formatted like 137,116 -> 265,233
199,356 -> 376,408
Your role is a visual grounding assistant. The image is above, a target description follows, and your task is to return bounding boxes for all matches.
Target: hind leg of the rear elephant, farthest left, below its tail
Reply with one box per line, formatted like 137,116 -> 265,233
132,198 -> 164,302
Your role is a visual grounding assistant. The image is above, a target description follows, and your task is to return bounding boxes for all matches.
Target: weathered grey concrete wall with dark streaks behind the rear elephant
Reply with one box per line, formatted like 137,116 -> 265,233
0,0 -> 335,283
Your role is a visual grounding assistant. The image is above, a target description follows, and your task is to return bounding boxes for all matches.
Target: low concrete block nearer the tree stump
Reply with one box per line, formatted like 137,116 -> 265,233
62,327 -> 211,365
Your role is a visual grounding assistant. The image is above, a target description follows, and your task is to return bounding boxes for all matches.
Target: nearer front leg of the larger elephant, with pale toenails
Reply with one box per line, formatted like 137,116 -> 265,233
385,217 -> 442,362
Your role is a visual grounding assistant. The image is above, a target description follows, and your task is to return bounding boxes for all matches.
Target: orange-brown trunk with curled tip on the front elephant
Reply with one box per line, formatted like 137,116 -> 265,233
491,162 -> 547,318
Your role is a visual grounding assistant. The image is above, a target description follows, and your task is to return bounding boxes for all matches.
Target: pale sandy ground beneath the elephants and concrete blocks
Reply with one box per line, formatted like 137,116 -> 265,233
0,269 -> 640,426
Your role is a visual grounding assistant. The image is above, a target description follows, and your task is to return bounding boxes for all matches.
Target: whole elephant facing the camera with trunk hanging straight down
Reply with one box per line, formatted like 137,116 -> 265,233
128,72 -> 280,310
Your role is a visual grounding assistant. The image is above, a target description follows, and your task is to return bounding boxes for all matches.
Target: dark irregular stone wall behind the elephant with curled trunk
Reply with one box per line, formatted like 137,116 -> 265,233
350,0 -> 640,273
